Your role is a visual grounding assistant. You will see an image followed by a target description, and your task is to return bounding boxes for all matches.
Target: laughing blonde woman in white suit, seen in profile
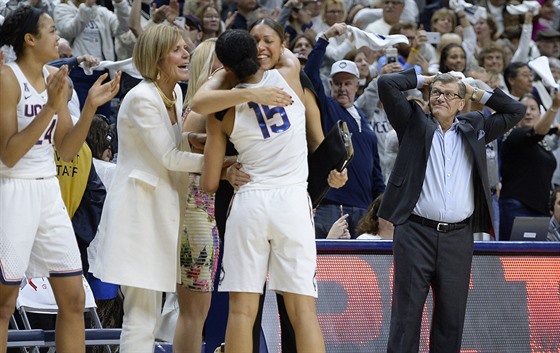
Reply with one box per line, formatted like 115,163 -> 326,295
86,24 -> 203,353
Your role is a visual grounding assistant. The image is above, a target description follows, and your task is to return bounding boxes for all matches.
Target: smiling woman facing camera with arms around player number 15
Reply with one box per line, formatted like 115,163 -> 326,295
191,18 -> 347,352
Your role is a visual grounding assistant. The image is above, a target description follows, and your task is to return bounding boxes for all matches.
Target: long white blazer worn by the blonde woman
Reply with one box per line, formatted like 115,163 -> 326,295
90,80 -> 203,292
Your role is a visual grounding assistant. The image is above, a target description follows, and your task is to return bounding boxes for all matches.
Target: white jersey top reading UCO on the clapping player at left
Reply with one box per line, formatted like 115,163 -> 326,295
0,62 -> 58,179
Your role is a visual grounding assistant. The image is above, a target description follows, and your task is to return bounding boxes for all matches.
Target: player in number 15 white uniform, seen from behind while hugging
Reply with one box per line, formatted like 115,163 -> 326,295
200,31 -> 325,353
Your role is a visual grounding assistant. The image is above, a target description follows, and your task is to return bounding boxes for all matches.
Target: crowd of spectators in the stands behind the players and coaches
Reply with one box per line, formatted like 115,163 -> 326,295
0,0 -> 560,350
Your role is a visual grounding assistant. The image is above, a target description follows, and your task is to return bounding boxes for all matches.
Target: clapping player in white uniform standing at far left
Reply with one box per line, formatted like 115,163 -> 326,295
0,6 -> 120,353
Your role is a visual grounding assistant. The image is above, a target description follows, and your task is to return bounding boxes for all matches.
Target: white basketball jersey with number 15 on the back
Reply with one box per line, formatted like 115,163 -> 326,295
230,70 -> 308,191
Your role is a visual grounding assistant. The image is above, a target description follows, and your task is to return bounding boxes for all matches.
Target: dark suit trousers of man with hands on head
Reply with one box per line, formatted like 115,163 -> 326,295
387,221 -> 474,353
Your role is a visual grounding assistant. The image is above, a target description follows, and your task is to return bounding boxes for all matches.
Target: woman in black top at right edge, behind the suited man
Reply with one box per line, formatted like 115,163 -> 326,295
500,92 -> 560,240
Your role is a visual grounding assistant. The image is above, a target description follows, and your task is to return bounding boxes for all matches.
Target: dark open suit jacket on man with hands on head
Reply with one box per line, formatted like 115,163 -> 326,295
378,69 -> 525,232
